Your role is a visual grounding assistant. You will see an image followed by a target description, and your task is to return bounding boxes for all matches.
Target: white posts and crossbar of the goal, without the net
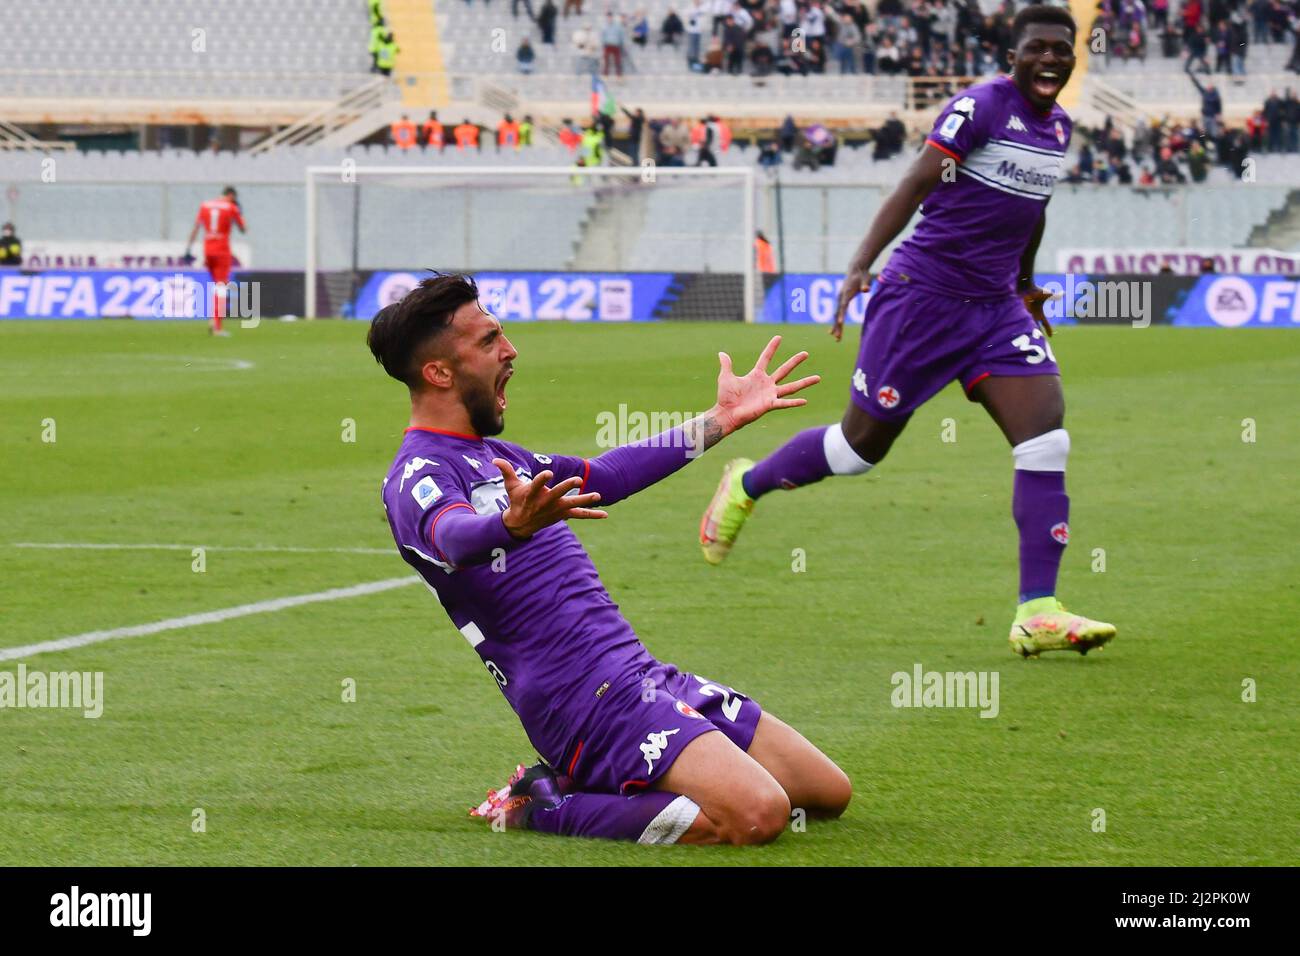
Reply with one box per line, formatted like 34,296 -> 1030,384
303,161 -> 758,323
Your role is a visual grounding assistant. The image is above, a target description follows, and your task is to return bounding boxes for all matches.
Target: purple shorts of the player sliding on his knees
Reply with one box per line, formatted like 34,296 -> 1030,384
566,663 -> 763,793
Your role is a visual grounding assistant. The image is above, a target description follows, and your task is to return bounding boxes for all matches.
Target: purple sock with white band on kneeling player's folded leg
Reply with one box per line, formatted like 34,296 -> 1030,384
528,790 -> 699,843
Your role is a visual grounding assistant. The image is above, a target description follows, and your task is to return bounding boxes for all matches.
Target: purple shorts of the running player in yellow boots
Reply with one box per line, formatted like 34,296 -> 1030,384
849,269 -> 1061,421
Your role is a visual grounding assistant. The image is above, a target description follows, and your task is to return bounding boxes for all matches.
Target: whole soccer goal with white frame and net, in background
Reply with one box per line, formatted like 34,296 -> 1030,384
303,160 -> 762,321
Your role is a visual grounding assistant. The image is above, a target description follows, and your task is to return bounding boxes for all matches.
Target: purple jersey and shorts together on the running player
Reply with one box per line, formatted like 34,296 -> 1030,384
849,77 -> 1071,421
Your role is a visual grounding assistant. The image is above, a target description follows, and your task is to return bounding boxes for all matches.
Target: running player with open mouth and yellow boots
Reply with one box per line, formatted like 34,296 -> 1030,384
699,5 -> 1115,657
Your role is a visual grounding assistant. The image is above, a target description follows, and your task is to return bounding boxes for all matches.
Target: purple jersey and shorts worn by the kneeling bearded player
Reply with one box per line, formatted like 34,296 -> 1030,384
382,428 -> 761,793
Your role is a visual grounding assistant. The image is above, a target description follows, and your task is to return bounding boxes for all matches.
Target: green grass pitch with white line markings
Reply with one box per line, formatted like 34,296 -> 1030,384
0,321 -> 1300,866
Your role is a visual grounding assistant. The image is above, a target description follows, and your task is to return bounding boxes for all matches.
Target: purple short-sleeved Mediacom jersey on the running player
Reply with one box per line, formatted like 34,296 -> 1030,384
889,77 -> 1073,298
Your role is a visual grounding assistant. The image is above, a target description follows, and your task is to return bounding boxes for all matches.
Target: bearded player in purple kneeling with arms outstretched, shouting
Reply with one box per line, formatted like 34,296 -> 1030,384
368,276 -> 852,844
